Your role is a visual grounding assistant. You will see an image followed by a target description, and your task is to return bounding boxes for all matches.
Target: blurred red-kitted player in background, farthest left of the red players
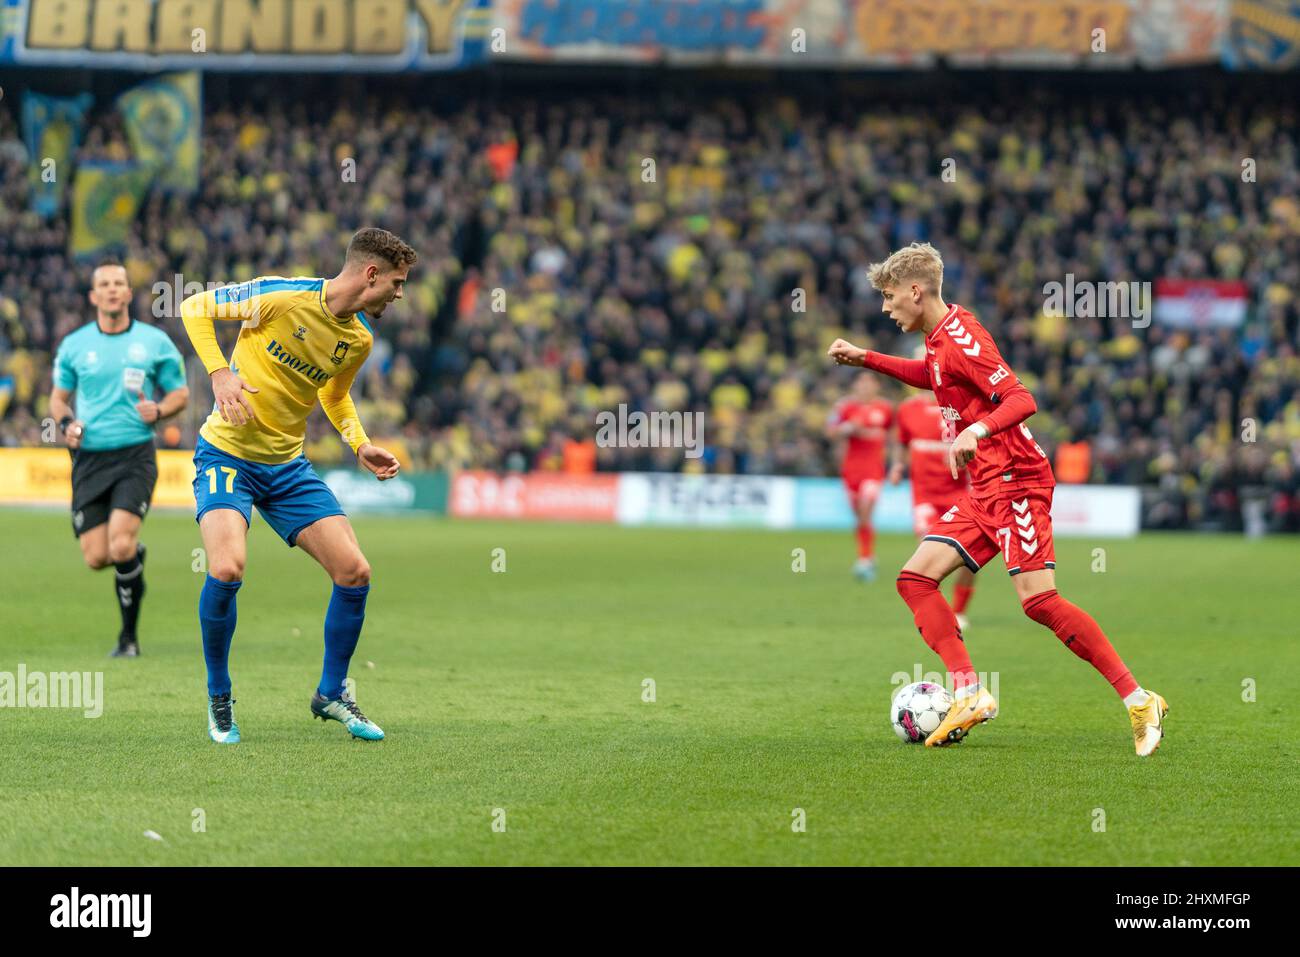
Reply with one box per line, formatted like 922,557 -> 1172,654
826,376 -> 893,581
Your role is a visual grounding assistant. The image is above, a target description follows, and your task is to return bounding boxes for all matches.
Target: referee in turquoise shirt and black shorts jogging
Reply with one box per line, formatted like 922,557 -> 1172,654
49,263 -> 190,658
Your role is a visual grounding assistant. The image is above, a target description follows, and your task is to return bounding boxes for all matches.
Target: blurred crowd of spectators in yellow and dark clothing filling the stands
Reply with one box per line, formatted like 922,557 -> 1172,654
0,74 -> 1300,529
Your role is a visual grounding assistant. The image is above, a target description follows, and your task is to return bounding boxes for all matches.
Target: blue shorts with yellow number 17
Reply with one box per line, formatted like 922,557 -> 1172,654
194,436 -> 343,547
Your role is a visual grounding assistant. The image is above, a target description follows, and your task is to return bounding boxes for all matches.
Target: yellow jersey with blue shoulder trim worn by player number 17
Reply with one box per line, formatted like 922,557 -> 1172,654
181,276 -> 374,464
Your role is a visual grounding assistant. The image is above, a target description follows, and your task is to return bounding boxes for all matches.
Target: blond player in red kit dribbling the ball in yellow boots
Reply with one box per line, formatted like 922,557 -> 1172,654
828,243 -> 1169,755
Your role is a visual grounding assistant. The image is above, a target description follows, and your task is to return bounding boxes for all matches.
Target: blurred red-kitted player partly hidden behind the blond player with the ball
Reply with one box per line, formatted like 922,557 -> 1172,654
894,382 -> 975,635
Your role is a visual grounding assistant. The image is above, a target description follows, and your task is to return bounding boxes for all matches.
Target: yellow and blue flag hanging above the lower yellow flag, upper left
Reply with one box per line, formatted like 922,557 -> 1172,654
117,70 -> 203,192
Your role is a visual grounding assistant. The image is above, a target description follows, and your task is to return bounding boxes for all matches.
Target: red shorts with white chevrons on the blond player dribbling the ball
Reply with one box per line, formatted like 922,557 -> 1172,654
924,489 -> 1056,575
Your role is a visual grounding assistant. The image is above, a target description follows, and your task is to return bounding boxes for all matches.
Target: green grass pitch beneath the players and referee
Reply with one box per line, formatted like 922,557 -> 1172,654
0,510 -> 1300,866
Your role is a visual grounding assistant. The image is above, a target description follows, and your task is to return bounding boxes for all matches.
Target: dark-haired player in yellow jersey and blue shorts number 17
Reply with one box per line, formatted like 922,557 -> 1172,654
181,229 -> 416,744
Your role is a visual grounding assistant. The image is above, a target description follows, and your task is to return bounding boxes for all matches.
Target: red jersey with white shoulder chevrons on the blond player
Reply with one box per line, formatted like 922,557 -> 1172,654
926,303 -> 1056,495
